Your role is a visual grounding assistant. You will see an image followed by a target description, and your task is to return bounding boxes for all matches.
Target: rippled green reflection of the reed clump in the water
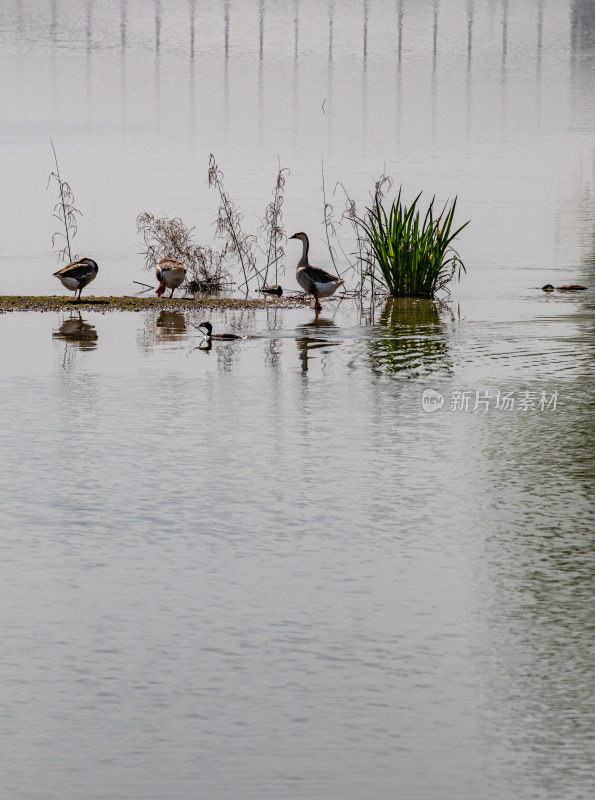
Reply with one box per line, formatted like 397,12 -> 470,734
368,298 -> 452,377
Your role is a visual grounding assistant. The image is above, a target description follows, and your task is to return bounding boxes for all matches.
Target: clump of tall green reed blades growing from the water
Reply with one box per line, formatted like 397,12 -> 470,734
357,189 -> 469,297
